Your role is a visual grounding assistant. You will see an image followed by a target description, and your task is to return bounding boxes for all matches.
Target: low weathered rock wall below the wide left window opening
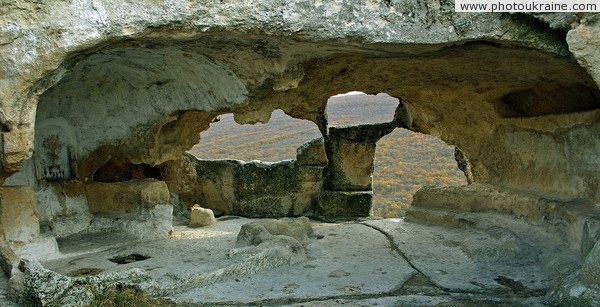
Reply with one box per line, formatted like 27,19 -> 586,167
164,155 -> 323,217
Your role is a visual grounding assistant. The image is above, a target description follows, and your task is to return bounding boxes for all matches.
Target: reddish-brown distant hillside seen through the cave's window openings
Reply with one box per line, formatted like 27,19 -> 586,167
189,94 -> 466,217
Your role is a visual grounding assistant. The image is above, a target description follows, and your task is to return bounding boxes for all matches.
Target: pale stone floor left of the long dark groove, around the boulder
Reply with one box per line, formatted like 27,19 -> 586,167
43,217 -> 415,304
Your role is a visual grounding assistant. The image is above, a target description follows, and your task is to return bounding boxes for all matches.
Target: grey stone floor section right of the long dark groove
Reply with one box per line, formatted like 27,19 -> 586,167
366,213 -> 581,296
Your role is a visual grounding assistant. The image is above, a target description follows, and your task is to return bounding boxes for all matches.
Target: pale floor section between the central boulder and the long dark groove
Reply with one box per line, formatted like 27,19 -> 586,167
171,224 -> 415,305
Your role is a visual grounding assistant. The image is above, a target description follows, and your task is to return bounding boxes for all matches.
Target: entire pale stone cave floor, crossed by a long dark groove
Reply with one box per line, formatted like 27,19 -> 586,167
0,213 -> 581,306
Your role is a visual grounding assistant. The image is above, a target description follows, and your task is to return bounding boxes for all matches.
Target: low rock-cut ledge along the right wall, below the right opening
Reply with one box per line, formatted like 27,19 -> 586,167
406,184 -> 600,255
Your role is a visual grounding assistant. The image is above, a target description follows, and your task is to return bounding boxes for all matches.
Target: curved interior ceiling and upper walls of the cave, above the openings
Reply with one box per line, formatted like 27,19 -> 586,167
10,37 -> 600,207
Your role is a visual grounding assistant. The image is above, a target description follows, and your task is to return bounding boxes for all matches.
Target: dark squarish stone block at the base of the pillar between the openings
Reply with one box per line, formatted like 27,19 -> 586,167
316,190 -> 373,219
